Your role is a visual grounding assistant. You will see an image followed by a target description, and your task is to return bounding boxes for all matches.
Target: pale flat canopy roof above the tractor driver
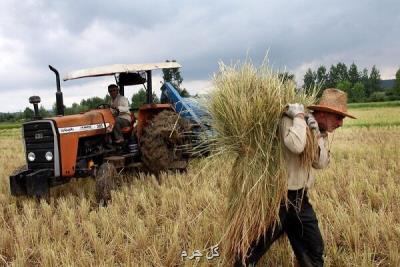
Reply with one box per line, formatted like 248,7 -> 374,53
64,61 -> 182,81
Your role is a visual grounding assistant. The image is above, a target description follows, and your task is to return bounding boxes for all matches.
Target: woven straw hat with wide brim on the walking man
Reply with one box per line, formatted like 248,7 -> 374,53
307,88 -> 356,119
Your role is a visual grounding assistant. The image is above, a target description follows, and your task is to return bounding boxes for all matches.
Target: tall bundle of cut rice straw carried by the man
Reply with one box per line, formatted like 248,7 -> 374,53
209,60 -> 316,265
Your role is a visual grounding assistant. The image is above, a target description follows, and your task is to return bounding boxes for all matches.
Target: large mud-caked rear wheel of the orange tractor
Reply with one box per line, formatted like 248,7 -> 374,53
139,110 -> 189,175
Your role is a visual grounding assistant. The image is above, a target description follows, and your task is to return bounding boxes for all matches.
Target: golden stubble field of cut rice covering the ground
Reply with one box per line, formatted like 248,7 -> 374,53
0,107 -> 400,266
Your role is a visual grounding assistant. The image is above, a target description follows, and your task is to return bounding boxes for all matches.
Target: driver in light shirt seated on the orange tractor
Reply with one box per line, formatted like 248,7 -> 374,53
108,84 -> 131,144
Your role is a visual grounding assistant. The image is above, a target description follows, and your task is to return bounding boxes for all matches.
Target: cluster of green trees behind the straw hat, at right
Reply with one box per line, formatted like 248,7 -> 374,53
303,62 -> 400,102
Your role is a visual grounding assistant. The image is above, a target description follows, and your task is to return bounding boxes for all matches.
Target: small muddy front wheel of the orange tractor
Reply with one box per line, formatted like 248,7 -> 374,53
96,162 -> 117,206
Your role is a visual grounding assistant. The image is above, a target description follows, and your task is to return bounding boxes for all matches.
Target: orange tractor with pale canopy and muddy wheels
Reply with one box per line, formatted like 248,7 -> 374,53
9,62 -> 208,201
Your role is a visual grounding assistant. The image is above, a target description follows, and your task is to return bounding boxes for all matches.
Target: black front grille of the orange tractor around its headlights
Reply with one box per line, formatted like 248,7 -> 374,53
23,121 -> 56,170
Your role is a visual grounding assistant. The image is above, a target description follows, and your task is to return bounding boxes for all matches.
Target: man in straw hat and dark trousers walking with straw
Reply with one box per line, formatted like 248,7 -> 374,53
234,89 -> 355,266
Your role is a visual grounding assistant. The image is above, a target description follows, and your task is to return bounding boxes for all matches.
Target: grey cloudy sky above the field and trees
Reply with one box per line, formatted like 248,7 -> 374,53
0,0 -> 400,112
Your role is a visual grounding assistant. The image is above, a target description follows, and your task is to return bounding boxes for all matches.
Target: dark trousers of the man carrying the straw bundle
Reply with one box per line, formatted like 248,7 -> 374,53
235,189 -> 324,267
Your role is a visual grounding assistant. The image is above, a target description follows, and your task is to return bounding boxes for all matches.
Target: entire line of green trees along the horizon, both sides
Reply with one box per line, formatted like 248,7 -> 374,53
0,60 -> 400,123
